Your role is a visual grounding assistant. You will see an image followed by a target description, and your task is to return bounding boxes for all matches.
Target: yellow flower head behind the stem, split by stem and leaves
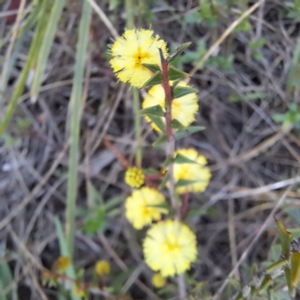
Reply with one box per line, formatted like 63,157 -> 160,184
142,81 -> 199,131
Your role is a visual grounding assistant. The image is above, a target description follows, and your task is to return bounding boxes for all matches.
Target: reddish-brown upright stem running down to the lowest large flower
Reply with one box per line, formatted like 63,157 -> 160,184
159,49 -> 180,219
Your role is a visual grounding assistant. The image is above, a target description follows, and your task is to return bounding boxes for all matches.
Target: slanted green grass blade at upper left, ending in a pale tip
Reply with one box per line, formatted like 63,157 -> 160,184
30,0 -> 66,101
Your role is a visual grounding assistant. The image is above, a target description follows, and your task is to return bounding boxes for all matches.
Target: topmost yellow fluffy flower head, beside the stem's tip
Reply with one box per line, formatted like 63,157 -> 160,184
110,29 -> 168,87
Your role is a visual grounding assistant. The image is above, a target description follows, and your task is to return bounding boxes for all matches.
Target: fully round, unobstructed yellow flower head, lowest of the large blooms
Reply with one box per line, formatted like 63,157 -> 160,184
143,220 -> 197,277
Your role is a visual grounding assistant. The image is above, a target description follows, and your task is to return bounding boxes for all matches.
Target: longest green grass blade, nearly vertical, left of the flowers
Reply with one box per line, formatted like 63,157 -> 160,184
66,1 -> 92,258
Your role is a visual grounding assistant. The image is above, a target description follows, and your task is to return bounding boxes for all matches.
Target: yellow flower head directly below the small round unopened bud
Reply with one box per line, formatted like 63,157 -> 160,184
125,187 -> 168,229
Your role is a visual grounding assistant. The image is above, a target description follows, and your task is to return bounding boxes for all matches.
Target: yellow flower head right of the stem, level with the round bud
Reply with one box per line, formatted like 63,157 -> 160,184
174,148 -> 211,194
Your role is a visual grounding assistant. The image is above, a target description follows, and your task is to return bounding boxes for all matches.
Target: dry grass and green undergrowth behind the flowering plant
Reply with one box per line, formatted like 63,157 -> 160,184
0,0 -> 300,300
